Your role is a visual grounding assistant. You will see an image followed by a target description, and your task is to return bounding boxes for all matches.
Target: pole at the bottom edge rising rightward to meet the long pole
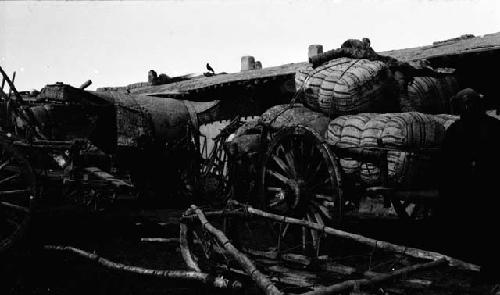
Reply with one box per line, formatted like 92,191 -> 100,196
305,258 -> 448,295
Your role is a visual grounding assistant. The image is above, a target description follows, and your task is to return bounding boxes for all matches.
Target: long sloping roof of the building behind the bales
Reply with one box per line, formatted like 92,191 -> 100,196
100,33 -> 500,104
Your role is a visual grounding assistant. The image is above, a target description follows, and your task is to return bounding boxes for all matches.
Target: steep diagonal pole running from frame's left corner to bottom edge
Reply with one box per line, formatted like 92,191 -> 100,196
191,205 -> 283,295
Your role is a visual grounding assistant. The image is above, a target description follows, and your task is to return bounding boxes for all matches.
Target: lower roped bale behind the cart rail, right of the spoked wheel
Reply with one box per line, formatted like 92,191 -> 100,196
325,112 -> 451,188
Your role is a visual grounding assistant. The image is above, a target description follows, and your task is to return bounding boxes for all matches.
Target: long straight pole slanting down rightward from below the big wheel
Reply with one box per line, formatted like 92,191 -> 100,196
226,201 -> 480,271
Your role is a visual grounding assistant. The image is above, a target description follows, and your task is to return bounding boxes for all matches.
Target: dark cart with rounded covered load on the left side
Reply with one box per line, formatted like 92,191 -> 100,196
0,66 -> 225,254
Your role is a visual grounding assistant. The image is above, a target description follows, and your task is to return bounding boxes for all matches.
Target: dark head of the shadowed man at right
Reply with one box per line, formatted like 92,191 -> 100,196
451,88 -> 485,118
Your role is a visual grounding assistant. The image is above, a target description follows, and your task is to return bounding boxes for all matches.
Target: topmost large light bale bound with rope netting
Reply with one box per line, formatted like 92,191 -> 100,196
295,58 -> 397,117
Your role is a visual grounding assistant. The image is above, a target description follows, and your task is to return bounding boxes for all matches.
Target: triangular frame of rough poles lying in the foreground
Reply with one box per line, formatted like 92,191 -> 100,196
180,201 -> 479,294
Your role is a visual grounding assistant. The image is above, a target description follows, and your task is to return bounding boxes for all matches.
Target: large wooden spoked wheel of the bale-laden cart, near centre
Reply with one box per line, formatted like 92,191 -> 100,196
257,126 -> 342,251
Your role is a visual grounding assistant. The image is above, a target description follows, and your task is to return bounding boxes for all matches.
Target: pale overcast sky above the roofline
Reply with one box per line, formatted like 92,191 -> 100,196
0,0 -> 500,90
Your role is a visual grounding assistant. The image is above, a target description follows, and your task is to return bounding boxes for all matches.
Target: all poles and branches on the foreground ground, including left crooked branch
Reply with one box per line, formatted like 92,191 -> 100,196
44,201 -> 479,295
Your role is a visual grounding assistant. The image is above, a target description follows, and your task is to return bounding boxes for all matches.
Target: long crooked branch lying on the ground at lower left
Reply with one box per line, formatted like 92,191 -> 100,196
43,245 -> 241,289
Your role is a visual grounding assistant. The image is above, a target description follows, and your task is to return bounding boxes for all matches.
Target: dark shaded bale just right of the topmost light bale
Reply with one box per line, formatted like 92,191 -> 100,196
400,76 -> 460,114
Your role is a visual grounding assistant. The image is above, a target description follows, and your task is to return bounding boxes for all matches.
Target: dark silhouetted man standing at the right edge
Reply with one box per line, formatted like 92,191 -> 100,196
436,88 -> 500,283
